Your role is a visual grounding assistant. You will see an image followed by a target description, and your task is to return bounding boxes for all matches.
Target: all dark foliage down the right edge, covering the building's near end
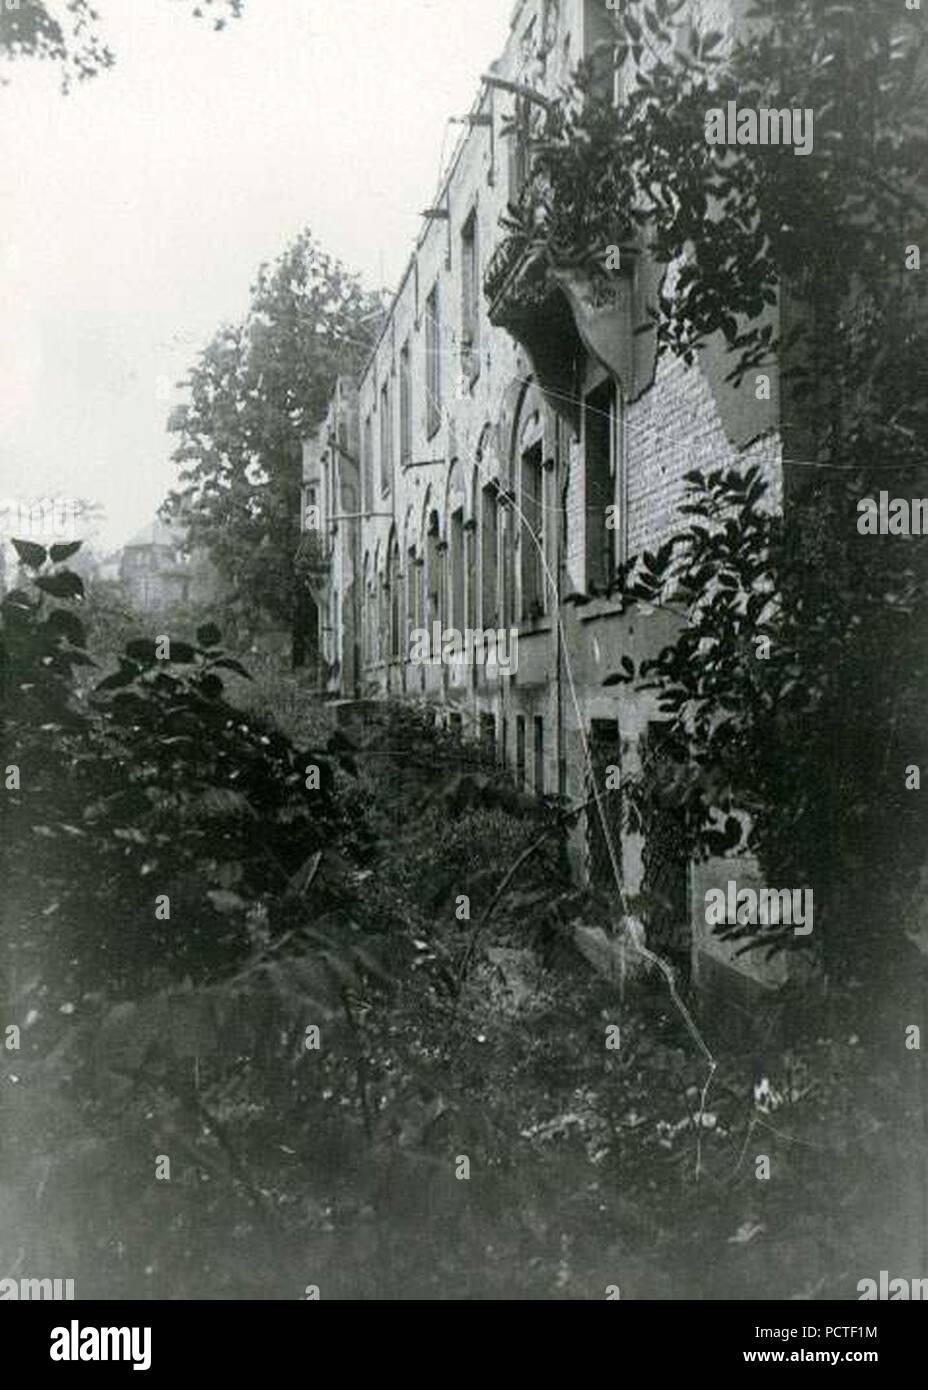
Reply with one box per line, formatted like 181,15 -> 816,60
492,0 -> 928,966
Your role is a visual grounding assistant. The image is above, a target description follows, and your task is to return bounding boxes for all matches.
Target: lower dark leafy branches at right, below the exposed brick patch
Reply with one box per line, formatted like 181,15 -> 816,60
608,467 -> 928,970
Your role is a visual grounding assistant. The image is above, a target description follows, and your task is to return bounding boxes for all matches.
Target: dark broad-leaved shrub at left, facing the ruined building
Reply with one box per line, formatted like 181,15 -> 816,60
0,541 -> 358,992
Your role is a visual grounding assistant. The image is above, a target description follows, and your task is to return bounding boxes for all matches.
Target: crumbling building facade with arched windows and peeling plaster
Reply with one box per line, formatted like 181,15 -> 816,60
301,0 -> 786,986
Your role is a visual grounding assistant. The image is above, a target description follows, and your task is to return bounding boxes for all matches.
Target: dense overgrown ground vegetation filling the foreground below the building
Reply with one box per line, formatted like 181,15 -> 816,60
0,543 -> 921,1298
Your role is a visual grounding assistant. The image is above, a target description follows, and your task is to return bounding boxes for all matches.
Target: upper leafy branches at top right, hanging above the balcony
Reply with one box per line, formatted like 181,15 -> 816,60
497,0 -> 928,380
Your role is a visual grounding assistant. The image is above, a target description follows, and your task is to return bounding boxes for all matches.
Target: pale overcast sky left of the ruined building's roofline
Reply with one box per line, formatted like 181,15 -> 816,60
0,0 -> 513,545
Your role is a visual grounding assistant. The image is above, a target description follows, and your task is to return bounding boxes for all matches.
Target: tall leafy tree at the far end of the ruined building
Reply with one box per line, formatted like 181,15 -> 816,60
164,229 -> 382,664
